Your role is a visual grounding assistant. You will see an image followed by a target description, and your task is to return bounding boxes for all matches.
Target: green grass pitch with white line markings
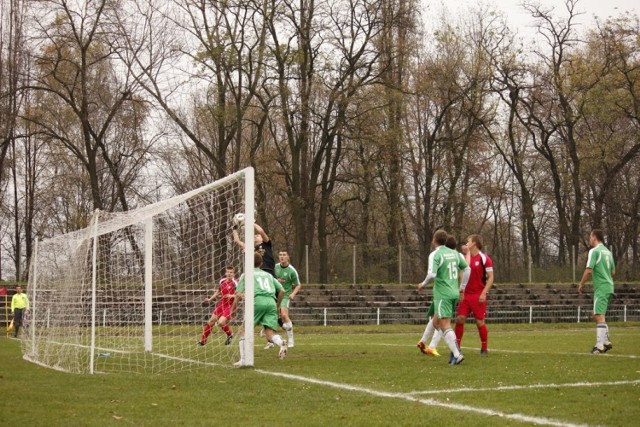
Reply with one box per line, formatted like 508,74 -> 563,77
0,323 -> 640,426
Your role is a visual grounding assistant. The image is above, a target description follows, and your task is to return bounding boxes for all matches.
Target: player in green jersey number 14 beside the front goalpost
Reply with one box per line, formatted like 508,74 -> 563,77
231,252 -> 287,366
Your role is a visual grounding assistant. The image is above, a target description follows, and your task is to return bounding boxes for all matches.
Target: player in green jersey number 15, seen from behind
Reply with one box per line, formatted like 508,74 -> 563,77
418,230 -> 470,365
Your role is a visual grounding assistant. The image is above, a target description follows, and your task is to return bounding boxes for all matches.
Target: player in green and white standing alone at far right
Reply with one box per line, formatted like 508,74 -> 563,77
578,229 -> 616,354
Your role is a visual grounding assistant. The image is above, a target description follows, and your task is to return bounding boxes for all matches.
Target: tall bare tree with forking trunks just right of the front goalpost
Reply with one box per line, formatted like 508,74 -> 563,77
269,0 -> 380,283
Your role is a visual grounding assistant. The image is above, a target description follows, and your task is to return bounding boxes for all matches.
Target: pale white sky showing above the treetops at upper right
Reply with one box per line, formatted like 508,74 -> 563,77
423,0 -> 640,37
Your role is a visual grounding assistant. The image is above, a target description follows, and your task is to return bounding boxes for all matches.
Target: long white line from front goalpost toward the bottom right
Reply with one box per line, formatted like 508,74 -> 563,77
255,369 -> 584,427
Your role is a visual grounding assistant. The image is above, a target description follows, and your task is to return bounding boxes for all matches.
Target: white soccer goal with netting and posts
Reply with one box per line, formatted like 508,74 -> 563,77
22,168 -> 254,373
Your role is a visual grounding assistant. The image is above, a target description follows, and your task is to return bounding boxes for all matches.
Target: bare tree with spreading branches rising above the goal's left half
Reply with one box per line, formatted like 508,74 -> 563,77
25,0 -> 146,214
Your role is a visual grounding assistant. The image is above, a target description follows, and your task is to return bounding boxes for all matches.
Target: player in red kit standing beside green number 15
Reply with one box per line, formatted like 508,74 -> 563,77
456,234 -> 493,356
